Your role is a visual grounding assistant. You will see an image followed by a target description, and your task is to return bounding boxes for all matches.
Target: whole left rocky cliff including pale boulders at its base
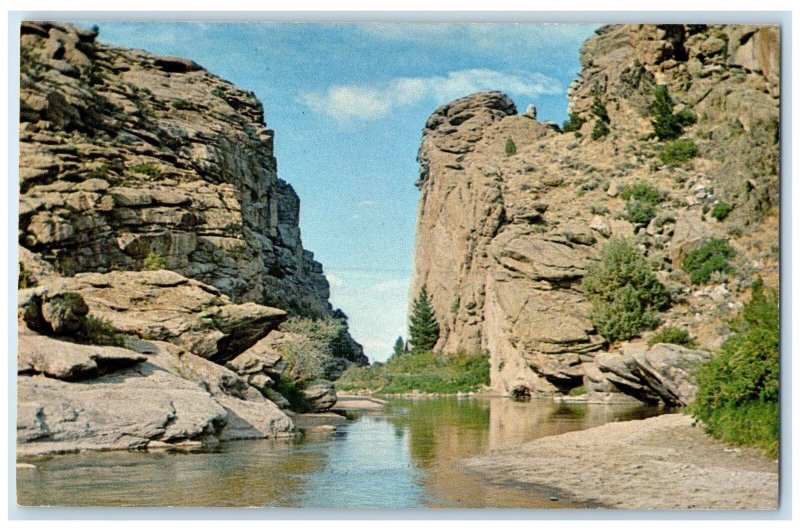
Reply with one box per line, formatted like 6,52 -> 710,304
18,22 -> 367,452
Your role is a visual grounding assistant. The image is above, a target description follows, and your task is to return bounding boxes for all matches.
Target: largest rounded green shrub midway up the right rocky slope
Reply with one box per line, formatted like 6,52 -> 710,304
582,238 -> 670,341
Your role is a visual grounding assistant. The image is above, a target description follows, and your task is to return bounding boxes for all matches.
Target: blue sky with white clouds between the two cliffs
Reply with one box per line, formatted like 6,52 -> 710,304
82,21 -> 597,361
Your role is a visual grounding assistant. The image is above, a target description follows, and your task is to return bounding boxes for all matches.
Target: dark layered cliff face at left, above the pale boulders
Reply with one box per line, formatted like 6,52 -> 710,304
19,22 -> 332,317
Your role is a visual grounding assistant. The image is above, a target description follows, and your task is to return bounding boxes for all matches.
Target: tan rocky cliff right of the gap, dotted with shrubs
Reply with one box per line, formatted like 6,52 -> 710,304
412,25 -> 780,403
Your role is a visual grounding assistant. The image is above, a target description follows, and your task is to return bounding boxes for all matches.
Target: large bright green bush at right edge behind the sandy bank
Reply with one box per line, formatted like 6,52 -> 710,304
690,280 -> 780,456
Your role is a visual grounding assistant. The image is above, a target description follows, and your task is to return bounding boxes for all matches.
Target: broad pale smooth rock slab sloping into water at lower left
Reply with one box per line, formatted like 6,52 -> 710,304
17,338 -> 294,454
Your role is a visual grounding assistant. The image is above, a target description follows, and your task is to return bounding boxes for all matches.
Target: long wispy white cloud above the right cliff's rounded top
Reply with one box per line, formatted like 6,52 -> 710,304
297,68 -> 563,122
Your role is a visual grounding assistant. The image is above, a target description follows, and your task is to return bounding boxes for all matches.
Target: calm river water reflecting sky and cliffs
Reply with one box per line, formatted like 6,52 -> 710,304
17,398 -> 659,508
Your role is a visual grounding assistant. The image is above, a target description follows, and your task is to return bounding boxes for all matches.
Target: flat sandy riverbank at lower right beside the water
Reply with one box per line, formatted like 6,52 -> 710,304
462,414 -> 778,509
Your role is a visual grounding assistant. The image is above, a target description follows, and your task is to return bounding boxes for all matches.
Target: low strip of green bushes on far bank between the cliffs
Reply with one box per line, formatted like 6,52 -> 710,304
336,351 -> 489,394
